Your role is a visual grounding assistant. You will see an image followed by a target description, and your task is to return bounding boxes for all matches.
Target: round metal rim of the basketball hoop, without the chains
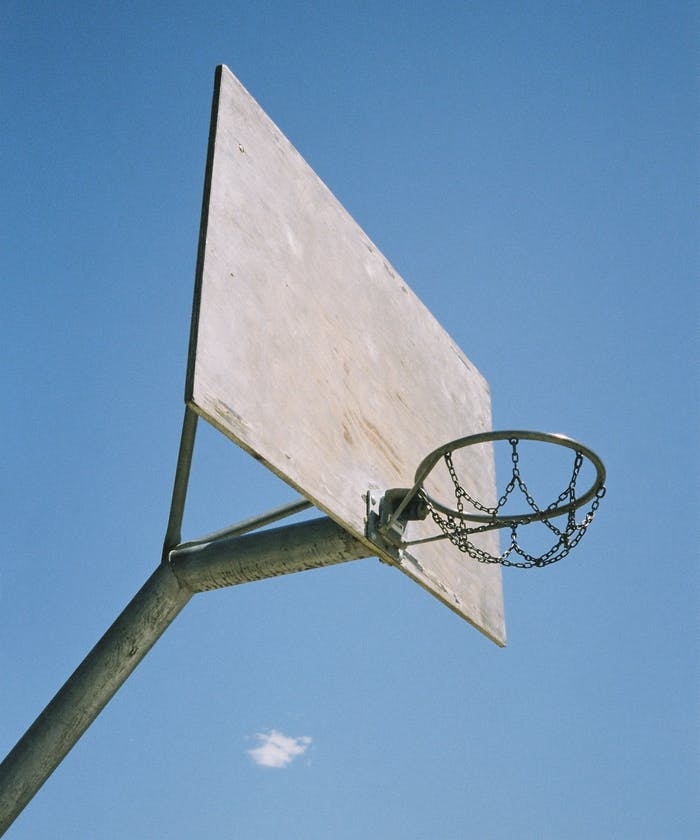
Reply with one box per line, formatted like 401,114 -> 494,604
415,430 -> 605,525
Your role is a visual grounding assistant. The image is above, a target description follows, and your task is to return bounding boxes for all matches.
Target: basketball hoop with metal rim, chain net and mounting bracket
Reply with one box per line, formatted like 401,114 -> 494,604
377,431 -> 605,569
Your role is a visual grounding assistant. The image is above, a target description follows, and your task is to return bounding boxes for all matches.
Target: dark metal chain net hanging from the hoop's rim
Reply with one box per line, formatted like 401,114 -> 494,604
425,438 -> 605,569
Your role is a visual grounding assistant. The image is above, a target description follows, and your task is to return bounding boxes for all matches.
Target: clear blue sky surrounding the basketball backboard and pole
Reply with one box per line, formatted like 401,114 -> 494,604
0,0 -> 700,840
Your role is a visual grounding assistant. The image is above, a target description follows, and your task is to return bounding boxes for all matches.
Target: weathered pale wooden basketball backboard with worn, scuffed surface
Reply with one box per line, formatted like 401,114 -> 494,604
186,66 -> 505,645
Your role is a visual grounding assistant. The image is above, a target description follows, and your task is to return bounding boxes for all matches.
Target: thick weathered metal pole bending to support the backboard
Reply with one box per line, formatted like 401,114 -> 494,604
0,517 -> 372,836
